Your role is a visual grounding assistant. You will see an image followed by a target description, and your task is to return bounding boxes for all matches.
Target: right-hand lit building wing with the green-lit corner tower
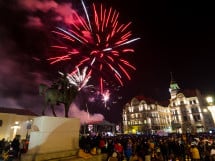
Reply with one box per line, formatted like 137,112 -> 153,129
169,79 -> 214,133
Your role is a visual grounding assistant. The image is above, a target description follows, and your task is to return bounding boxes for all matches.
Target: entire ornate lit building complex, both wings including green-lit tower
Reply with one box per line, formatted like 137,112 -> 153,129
122,79 -> 215,134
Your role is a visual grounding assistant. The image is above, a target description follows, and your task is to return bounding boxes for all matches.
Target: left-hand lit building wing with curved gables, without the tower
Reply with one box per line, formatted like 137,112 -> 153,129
123,97 -> 171,134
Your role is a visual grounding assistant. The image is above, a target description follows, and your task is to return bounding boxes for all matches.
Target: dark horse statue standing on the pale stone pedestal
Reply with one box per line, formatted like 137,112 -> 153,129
39,78 -> 78,117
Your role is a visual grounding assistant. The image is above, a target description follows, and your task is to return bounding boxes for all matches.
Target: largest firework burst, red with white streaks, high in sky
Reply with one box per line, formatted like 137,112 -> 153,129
48,1 -> 139,96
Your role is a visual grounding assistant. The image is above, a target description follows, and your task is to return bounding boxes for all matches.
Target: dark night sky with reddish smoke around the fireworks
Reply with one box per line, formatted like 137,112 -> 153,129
0,0 -> 215,123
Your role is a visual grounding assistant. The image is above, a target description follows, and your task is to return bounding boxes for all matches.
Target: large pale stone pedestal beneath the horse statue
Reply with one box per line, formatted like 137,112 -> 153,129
21,116 -> 80,161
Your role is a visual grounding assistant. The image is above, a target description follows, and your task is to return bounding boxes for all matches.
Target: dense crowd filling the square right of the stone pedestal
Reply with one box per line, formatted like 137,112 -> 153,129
79,133 -> 215,161
